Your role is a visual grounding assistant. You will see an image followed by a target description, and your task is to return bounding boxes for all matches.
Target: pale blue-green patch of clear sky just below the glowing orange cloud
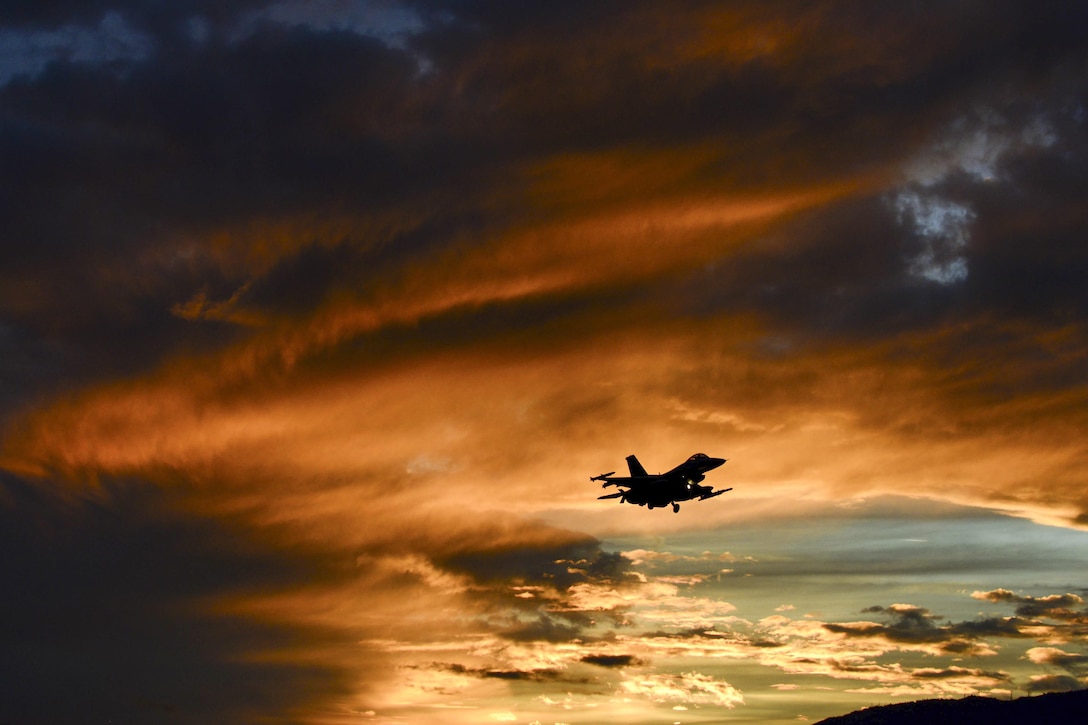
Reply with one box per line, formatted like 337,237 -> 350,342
604,497 -> 1088,620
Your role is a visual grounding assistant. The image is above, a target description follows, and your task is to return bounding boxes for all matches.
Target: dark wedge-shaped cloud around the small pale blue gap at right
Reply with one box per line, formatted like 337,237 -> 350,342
684,95 -> 1088,339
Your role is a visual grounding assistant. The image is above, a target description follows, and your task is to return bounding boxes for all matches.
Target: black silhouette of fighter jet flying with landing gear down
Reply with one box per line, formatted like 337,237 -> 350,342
590,453 -> 732,513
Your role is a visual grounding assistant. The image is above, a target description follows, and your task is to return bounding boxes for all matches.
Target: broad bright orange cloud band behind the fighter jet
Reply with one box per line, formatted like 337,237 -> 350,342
4,293 -> 1085,535
